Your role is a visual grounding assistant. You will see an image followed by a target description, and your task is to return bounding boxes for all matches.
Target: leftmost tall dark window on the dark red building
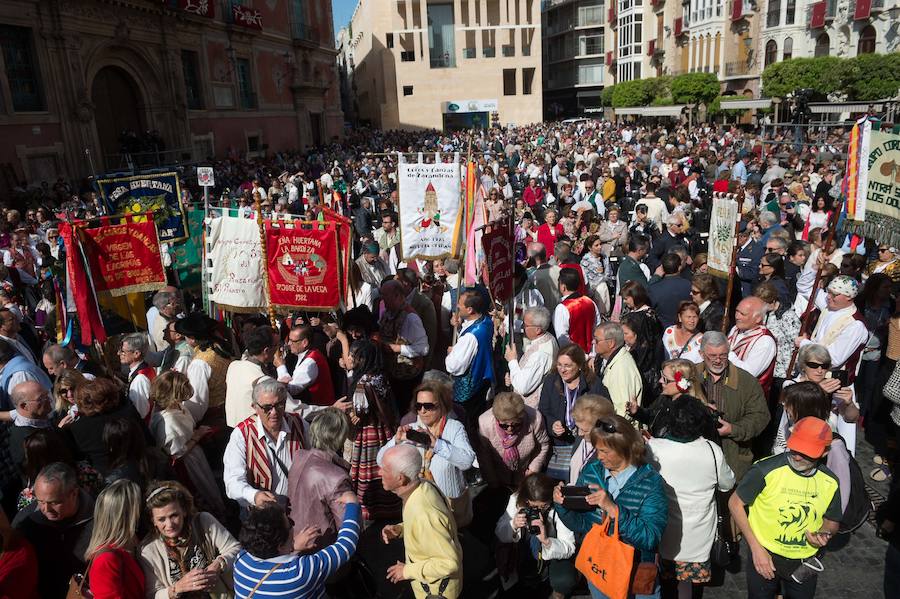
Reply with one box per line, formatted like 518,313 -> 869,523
0,25 -> 46,112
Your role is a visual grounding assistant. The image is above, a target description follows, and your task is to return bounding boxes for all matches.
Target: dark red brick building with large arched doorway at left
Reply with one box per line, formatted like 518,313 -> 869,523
0,0 -> 343,188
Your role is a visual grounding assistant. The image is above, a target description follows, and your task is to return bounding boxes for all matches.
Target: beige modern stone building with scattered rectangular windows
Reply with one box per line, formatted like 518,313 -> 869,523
340,0 -> 542,129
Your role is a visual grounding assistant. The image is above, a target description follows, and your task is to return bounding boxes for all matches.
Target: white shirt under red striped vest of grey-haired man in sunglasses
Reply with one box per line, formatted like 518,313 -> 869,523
223,416 -> 305,505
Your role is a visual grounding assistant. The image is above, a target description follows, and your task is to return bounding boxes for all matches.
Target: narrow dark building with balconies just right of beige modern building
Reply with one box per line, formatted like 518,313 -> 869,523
541,0 -> 615,118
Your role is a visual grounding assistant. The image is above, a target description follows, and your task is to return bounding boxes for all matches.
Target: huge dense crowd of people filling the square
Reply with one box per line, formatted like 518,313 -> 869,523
0,121 -> 900,599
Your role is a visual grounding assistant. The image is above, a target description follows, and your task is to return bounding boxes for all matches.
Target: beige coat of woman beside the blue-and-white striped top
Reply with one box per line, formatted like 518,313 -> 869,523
140,512 -> 241,599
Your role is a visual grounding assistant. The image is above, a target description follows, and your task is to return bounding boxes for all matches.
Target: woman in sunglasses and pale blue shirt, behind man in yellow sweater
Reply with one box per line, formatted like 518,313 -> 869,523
378,381 -> 475,528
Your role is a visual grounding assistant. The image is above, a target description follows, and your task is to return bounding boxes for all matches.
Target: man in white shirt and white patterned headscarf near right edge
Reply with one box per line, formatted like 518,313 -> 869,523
795,275 -> 869,454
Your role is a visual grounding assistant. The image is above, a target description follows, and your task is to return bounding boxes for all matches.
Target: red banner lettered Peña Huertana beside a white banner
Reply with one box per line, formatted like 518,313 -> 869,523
266,221 -> 341,311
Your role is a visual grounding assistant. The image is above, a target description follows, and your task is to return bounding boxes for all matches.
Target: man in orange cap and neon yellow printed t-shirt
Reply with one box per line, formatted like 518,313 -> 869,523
728,416 -> 842,599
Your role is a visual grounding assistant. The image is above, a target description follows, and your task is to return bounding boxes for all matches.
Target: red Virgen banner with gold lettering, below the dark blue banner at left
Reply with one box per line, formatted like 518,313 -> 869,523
79,218 -> 166,297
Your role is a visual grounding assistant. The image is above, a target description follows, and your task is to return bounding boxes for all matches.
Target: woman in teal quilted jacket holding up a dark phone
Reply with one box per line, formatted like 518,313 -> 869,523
553,415 -> 669,599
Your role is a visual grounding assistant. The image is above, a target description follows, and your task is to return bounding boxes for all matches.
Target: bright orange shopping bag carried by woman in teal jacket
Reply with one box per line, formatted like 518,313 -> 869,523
575,516 -> 634,599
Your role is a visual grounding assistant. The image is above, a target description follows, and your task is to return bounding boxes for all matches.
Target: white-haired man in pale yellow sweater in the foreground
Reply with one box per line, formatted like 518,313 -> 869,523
381,445 -> 462,599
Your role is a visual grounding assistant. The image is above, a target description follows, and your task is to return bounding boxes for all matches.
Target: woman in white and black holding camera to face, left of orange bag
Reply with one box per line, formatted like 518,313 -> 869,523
494,472 -> 578,599
